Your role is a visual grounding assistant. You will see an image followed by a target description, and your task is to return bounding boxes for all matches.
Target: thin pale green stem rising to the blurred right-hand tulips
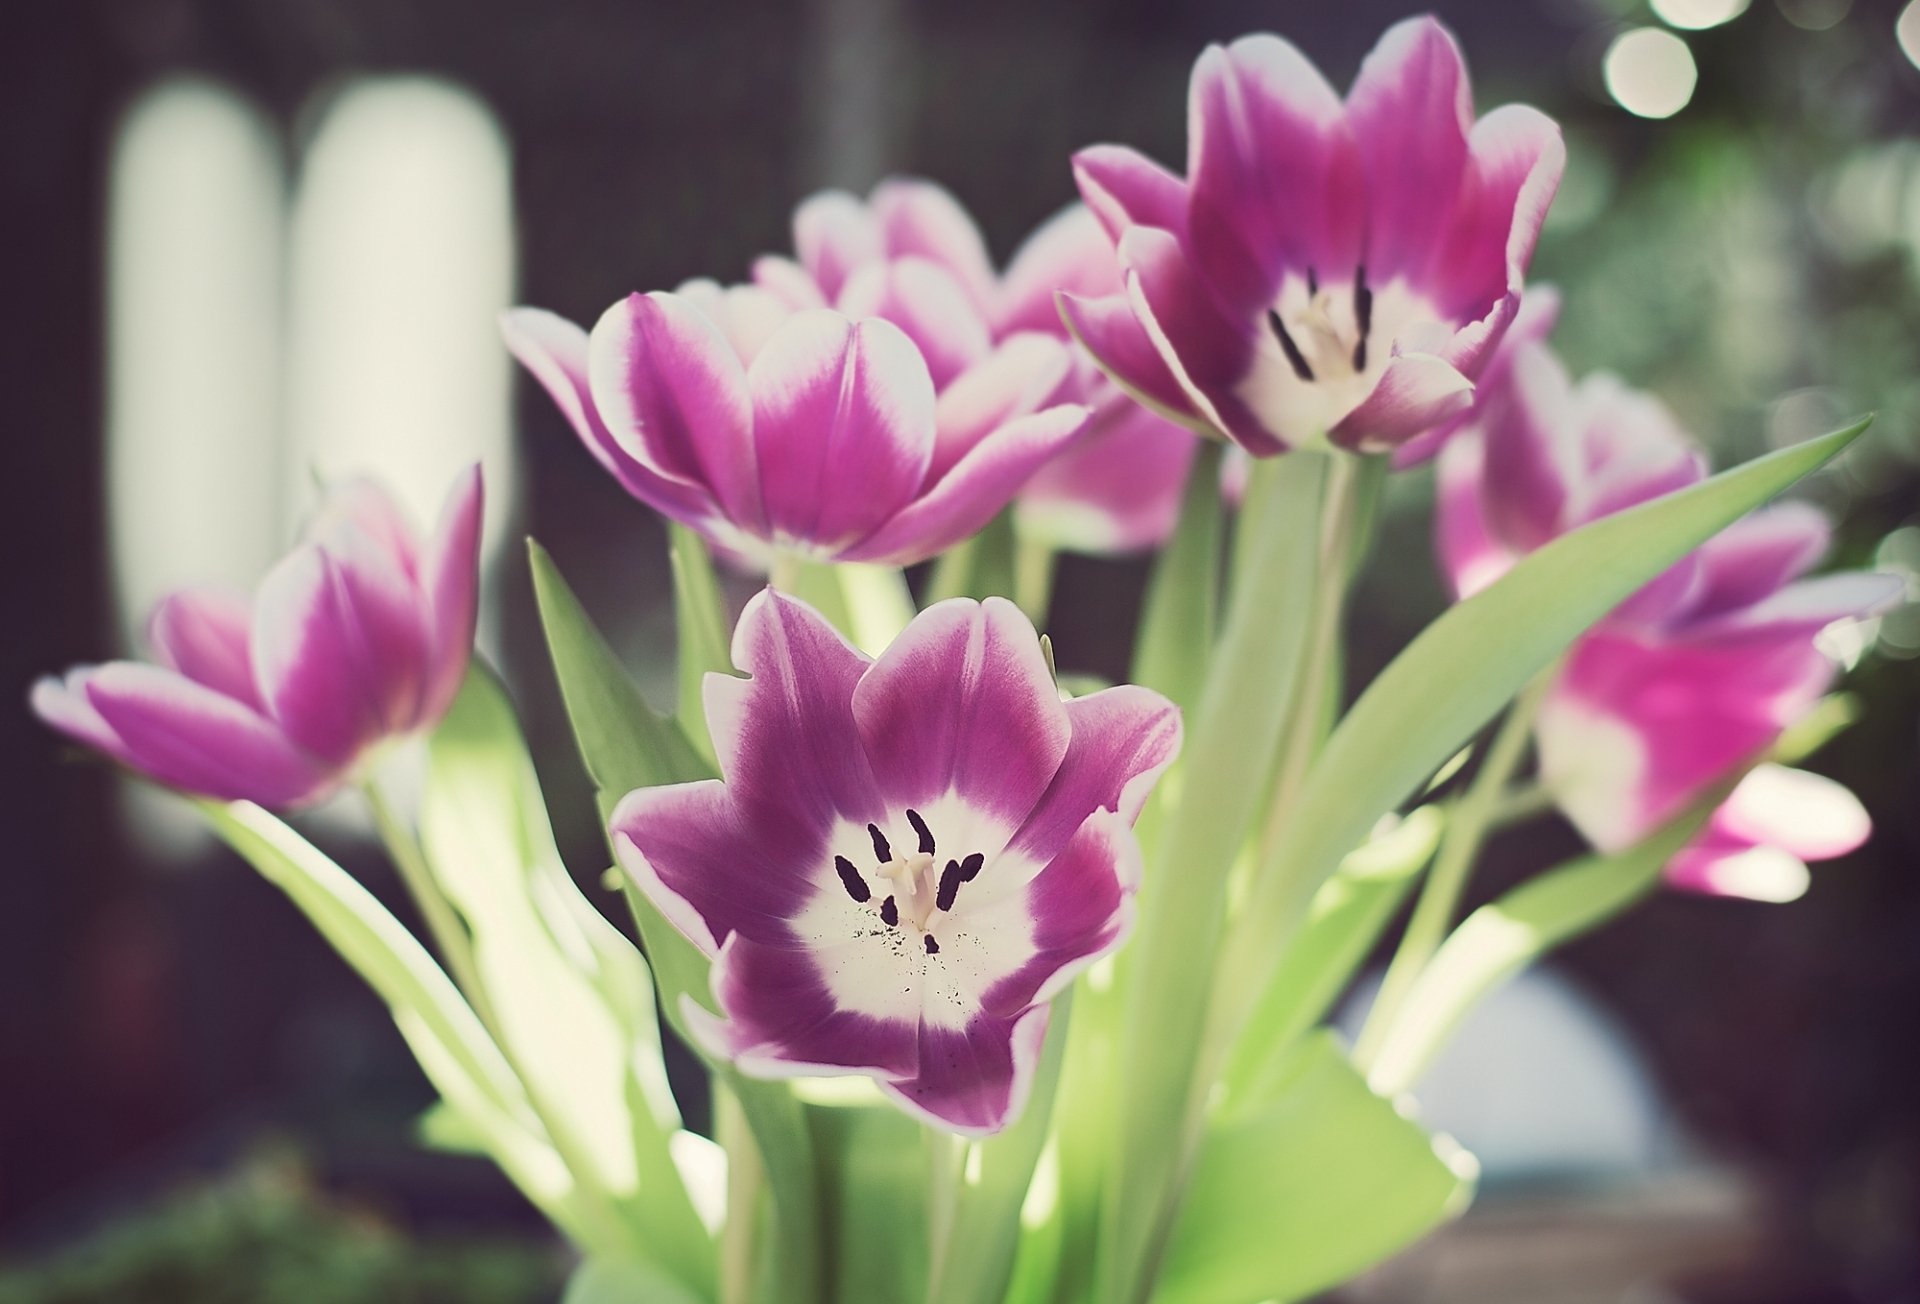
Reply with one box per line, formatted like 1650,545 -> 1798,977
1354,668 -> 1553,1072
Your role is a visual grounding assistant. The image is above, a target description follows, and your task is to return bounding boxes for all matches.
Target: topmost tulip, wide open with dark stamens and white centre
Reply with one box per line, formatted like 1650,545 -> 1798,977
1062,17 -> 1565,455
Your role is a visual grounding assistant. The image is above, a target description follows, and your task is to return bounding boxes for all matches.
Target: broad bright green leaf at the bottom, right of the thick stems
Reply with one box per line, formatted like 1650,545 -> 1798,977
1152,1033 -> 1476,1304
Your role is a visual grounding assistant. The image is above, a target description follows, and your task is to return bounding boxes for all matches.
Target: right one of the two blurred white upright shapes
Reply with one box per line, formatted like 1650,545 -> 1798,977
288,77 -> 515,603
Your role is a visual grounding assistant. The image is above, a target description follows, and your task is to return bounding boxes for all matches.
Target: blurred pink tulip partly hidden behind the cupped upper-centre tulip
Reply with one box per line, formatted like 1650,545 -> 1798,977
760,177 -> 1194,553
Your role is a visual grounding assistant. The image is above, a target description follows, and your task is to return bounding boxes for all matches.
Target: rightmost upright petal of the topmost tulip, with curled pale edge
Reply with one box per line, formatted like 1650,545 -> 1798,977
1425,104 -> 1567,321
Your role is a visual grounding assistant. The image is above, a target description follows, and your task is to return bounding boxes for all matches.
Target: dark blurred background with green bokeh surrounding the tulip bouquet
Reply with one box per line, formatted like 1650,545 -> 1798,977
0,0 -> 1920,1302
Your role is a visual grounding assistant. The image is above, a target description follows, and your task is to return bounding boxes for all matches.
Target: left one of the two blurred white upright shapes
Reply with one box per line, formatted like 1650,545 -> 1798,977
106,81 -> 286,647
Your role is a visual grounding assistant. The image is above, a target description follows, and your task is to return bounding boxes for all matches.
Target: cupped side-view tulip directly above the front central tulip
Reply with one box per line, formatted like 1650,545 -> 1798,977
505,290 -> 1087,565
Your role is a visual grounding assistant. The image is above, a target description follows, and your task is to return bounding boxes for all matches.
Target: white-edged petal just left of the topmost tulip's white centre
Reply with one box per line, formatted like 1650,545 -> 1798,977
1119,227 -> 1284,457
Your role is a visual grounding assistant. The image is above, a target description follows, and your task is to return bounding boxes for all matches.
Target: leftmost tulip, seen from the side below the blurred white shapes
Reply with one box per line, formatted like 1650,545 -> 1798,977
33,467 -> 482,807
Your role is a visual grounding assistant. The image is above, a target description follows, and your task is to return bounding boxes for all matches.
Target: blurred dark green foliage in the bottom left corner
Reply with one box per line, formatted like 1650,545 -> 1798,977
0,1152 -> 563,1304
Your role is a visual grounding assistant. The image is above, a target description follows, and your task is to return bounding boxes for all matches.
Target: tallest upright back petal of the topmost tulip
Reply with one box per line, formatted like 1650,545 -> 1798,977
1348,17 -> 1466,286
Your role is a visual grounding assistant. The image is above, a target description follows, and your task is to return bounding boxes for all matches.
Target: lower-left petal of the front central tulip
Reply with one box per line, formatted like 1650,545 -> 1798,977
687,933 -> 920,1077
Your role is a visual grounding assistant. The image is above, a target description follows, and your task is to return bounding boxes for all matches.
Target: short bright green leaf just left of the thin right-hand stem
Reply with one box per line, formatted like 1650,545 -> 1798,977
1221,807 -> 1446,1114
